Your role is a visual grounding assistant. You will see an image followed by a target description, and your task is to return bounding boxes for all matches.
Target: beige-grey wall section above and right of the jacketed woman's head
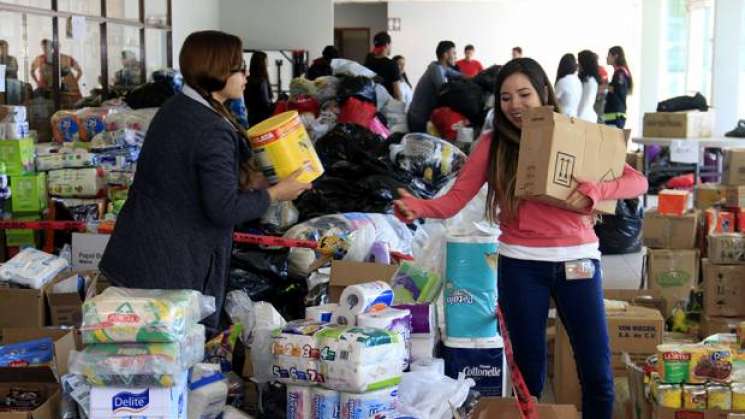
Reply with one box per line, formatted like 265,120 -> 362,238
220,0 -> 334,59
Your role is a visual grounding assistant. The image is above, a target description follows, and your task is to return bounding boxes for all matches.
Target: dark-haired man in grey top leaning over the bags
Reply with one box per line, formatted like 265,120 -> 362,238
406,41 -> 463,132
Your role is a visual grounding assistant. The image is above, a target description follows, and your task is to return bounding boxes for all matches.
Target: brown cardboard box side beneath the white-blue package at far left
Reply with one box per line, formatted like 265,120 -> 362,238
0,285 -> 49,328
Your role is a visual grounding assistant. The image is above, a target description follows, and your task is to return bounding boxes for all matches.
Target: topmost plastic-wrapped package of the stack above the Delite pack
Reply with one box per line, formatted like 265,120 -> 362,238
81,287 -> 215,344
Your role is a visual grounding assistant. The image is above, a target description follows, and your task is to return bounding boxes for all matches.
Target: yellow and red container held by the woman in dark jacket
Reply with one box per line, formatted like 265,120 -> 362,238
248,111 -> 323,183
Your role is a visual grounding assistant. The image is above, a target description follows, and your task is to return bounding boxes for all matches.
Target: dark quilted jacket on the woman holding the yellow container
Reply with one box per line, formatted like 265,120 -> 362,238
99,93 -> 270,328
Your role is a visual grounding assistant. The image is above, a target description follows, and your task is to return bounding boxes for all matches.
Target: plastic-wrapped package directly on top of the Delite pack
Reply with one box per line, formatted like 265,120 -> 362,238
69,324 -> 205,387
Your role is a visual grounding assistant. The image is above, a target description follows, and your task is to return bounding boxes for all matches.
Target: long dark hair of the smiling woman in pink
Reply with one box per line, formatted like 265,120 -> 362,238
486,58 -> 559,222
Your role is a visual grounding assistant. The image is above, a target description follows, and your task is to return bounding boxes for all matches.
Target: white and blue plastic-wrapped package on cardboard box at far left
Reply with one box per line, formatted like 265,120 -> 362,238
0,248 -> 69,289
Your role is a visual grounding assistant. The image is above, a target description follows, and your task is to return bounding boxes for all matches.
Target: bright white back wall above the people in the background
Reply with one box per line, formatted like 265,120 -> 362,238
388,0 -> 647,133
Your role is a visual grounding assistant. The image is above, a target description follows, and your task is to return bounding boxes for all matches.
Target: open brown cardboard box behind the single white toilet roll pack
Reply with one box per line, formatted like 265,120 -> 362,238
329,260 -> 398,303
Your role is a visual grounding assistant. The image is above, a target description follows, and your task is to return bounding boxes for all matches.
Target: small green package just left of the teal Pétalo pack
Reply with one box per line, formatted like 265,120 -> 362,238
391,262 -> 442,305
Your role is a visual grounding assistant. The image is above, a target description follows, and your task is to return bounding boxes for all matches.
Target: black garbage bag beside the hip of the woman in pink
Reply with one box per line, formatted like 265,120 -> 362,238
595,198 -> 644,255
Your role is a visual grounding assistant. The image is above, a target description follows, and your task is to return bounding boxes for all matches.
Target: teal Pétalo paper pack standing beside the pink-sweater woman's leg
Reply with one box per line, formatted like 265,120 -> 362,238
444,236 -> 497,338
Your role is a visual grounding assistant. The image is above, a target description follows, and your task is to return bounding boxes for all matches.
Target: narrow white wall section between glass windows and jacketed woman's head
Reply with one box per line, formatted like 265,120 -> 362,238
171,0 -> 225,68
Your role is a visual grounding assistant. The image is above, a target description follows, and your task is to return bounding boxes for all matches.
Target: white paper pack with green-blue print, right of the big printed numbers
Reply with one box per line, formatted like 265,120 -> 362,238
316,326 -> 404,393
